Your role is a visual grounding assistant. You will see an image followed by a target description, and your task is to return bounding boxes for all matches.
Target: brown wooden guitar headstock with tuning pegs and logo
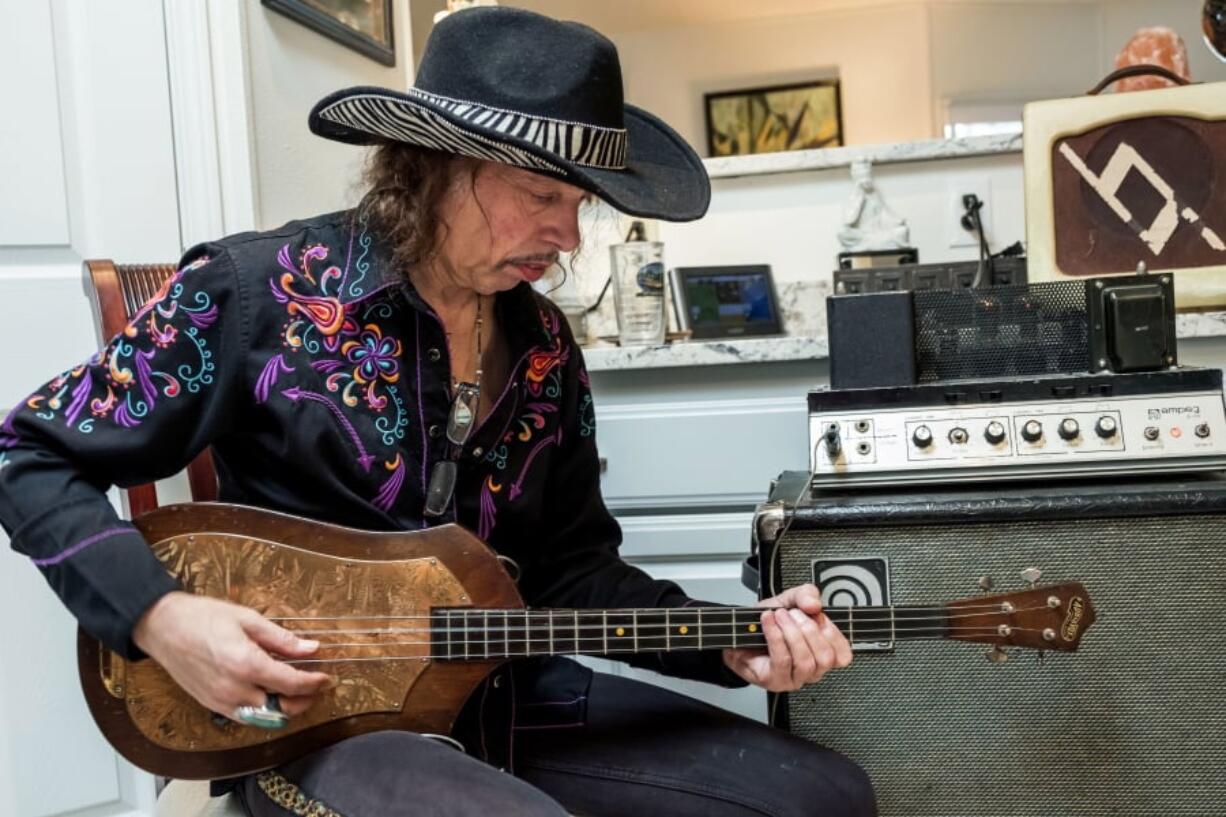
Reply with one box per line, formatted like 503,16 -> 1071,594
945,581 -> 1095,658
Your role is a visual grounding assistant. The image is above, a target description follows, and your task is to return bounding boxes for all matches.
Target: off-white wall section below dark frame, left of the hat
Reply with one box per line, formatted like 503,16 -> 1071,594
244,0 -> 413,228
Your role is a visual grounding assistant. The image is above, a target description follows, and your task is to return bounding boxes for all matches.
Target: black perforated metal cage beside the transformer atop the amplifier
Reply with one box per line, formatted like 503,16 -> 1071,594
913,281 -> 1090,383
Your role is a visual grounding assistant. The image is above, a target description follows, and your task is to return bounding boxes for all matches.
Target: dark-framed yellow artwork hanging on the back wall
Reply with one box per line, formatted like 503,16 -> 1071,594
702,80 -> 843,156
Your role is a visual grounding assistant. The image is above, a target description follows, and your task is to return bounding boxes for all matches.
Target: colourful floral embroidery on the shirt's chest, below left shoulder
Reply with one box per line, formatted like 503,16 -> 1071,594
255,233 -> 408,502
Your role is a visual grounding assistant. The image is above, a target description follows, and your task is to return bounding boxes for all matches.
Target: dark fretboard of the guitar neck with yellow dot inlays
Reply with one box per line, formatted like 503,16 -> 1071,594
430,606 -> 949,660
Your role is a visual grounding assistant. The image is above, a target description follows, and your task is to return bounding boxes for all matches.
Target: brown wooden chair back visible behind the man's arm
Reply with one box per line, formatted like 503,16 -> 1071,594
85,259 -> 217,518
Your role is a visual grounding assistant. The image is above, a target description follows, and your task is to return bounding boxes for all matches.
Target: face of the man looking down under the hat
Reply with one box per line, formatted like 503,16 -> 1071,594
439,162 -> 590,294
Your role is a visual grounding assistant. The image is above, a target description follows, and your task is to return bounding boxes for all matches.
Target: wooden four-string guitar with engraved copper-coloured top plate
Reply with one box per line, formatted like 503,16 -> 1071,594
77,503 -> 1095,779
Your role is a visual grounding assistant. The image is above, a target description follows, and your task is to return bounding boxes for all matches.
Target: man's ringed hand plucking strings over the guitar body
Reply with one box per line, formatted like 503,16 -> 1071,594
132,591 -> 332,718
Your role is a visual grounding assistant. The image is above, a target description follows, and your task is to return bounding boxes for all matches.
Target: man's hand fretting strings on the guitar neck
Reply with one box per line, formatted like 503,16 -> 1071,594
723,584 -> 851,692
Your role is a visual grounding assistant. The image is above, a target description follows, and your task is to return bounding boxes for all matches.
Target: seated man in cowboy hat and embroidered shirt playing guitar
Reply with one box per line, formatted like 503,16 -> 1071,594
0,7 -> 874,817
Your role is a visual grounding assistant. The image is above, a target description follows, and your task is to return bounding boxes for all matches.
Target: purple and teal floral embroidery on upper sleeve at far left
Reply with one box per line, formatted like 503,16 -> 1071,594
26,256 -> 218,434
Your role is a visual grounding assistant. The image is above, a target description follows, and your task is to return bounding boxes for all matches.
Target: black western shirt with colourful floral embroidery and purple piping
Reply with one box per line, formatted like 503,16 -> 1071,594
0,204 -> 734,701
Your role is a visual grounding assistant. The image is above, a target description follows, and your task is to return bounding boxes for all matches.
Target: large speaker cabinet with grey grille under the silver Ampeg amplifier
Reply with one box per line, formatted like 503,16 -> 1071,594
756,474 -> 1226,817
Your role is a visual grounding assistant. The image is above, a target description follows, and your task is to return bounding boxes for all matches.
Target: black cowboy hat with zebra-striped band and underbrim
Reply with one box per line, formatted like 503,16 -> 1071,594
310,6 -> 711,221
